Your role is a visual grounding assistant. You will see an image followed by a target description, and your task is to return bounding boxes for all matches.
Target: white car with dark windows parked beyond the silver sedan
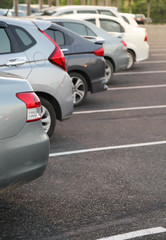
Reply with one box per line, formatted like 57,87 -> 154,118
68,14 -> 149,69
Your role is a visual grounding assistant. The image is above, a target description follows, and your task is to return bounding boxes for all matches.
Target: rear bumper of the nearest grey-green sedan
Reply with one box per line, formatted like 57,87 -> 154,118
0,121 -> 49,192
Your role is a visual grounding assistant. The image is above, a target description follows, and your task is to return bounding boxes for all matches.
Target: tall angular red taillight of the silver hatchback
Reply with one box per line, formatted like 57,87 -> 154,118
40,30 -> 67,72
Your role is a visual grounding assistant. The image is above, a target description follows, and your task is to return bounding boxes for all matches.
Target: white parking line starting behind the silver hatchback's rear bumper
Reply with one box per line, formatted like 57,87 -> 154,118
73,105 -> 166,115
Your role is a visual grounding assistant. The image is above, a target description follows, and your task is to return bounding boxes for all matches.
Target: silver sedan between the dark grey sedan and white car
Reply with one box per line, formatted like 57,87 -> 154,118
48,14 -> 128,83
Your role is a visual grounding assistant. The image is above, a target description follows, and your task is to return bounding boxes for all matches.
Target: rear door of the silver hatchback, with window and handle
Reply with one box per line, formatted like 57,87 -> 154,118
0,24 -> 33,78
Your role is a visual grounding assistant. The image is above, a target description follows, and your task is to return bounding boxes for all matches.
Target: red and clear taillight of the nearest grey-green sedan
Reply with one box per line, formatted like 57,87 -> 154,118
16,92 -> 41,122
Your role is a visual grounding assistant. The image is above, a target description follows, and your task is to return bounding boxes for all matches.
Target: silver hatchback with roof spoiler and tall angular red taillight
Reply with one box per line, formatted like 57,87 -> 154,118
0,17 -> 73,136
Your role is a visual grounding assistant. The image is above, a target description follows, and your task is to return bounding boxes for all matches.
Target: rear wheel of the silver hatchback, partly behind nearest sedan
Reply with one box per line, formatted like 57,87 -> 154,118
39,97 -> 56,137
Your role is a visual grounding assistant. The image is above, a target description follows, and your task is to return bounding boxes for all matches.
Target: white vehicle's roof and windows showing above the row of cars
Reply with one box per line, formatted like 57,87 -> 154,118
31,5 -> 122,19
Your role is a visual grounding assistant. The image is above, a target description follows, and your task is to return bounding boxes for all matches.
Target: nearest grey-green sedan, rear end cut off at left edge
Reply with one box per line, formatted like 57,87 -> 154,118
0,72 -> 49,193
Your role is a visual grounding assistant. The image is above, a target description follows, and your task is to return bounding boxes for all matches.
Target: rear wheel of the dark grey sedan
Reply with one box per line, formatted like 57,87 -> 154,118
69,72 -> 88,107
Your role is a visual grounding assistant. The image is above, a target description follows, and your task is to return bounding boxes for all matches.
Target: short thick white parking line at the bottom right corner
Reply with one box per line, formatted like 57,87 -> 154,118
98,227 -> 166,240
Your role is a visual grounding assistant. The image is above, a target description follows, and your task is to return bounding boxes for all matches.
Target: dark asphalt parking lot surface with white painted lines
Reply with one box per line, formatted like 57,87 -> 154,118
0,25 -> 166,240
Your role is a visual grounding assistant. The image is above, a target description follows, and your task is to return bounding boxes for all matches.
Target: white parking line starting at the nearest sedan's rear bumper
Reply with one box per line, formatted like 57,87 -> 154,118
49,141 -> 166,157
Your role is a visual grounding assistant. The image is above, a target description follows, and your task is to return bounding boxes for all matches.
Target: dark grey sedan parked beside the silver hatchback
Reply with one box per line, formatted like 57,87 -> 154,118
45,24 -> 107,106
